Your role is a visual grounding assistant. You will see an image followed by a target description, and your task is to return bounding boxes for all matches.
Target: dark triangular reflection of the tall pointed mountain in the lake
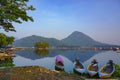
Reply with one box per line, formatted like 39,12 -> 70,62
54,50 -> 104,62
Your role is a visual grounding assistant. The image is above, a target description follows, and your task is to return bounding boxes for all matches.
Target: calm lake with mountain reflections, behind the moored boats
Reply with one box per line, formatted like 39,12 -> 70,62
0,49 -> 120,72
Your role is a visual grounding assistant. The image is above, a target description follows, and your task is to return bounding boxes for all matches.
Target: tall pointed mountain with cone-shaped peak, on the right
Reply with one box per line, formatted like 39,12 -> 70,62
61,31 -> 108,46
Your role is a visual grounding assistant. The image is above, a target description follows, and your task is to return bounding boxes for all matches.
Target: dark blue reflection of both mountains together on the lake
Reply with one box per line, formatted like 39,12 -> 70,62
16,50 -> 101,62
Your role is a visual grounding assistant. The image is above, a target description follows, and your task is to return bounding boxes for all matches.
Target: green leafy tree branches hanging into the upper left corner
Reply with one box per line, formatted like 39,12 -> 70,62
0,0 -> 35,32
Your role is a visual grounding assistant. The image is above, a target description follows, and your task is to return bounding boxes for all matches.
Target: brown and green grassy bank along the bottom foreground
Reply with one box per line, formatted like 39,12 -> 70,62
0,65 -> 120,80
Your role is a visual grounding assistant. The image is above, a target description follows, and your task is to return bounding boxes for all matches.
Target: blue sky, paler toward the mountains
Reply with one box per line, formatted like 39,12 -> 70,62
0,0 -> 120,45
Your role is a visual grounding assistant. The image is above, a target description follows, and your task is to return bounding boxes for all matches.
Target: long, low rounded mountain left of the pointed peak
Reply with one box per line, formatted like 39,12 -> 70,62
14,35 -> 62,47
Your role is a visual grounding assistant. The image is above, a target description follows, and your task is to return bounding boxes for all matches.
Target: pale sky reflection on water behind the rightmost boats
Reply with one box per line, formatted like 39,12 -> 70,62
84,51 -> 120,67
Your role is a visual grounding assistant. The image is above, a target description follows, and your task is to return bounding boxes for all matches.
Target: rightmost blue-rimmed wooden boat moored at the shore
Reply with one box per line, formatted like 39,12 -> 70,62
98,64 -> 115,78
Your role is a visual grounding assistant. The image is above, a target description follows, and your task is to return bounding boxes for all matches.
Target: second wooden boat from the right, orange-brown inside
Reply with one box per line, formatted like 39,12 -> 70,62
87,63 -> 98,77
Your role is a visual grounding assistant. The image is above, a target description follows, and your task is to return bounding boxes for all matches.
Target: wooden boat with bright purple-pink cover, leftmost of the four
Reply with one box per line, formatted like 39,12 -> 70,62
55,55 -> 64,71
